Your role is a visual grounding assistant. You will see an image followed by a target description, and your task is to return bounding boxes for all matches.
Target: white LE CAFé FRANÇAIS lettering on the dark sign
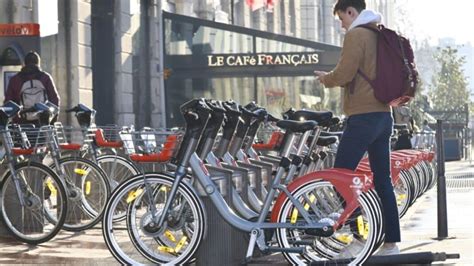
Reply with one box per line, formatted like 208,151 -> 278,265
207,53 -> 319,67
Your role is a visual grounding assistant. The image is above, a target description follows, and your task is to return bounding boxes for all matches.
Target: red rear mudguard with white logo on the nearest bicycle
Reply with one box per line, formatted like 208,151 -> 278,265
271,168 -> 374,228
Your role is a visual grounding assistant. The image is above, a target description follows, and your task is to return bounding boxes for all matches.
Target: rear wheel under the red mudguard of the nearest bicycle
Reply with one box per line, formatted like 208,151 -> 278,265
276,180 -> 381,265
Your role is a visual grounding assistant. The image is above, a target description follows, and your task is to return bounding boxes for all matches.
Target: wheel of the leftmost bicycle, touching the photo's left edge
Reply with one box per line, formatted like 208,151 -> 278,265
0,162 -> 67,245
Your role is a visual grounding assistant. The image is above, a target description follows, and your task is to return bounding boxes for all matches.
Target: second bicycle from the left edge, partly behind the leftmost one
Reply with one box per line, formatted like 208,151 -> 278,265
22,102 -> 110,232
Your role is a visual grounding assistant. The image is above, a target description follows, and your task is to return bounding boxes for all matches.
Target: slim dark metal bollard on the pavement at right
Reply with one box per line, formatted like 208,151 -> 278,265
436,120 -> 448,239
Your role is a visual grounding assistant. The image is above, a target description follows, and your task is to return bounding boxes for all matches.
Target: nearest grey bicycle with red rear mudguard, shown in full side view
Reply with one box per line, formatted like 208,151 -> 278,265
102,99 -> 381,265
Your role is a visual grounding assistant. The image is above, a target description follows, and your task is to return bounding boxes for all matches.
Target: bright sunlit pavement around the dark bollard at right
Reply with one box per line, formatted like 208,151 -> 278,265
400,161 -> 474,265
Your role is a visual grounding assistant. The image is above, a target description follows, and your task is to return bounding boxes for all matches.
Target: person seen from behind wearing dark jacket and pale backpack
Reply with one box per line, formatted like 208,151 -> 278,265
4,51 -> 59,124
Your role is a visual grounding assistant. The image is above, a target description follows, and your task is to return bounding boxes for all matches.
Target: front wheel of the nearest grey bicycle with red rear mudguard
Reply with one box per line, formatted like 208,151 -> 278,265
102,173 -> 206,265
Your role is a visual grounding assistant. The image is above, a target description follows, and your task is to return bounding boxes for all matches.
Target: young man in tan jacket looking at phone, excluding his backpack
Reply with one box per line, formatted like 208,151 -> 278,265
315,0 -> 400,255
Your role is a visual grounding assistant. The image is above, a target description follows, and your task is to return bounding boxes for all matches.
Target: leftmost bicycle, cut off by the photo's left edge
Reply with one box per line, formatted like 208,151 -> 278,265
0,101 -> 68,245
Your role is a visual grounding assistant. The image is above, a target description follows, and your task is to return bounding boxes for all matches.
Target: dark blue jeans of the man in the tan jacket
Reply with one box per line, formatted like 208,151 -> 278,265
334,112 -> 400,242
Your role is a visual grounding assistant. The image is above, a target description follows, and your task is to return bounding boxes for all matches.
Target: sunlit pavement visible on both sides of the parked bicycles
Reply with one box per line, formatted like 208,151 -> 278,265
0,161 -> 474,265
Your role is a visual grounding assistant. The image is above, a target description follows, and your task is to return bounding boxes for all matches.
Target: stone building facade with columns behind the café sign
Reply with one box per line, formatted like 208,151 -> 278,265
0,0 -> 393,127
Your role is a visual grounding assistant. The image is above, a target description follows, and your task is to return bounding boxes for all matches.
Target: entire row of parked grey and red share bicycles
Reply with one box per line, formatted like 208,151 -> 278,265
0,99 -> 436,265
